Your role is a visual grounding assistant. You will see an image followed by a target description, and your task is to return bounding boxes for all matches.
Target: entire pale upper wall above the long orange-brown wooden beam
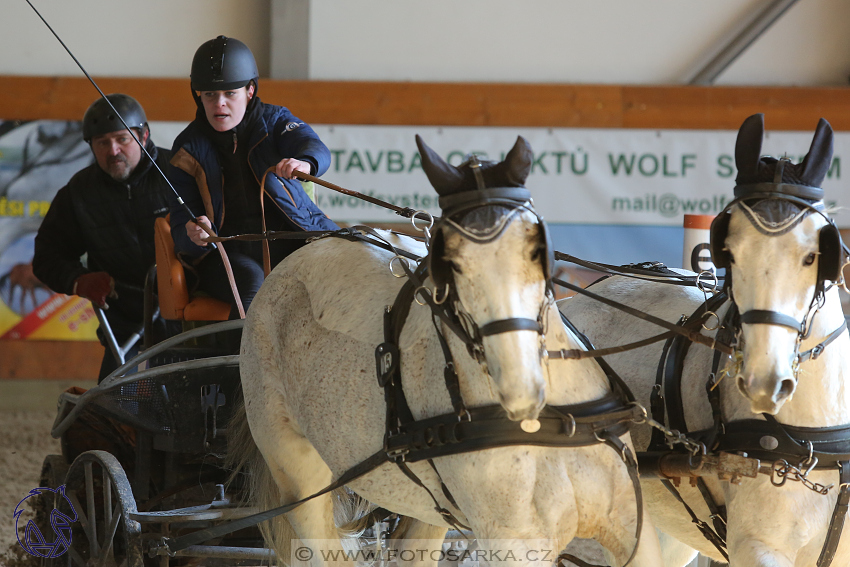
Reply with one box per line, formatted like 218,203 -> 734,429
0,0 -> 850,85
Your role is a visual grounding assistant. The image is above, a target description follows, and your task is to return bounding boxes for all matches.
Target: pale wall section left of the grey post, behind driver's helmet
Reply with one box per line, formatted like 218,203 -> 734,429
0,0 -> 269,79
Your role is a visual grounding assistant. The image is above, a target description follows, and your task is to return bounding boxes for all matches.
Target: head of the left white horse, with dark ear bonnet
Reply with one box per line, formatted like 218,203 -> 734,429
416,136 -> 552,420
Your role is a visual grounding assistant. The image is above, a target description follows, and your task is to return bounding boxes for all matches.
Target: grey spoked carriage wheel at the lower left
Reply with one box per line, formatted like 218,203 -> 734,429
57,451 -> 143,567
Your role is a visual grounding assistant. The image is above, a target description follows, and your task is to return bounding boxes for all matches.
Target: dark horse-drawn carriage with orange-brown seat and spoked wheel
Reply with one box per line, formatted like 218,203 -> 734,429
29,219 -> 262,567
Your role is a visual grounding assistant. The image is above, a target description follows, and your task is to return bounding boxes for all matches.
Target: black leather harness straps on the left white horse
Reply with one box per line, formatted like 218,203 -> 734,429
162,195 -> 643,566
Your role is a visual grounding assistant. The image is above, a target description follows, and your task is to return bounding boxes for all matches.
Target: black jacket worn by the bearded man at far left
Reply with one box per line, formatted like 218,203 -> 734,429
32,140 -> 171,324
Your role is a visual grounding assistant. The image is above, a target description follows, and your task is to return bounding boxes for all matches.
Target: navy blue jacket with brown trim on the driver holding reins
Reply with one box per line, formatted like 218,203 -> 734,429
168,101 -> 339,258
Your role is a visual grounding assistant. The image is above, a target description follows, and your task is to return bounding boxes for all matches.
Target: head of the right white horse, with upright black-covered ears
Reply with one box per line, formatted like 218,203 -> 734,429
711,114 -> 843,414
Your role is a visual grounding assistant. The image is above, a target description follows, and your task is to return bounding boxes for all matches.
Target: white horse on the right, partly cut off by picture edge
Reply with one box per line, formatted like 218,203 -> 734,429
561,115 -> 850,567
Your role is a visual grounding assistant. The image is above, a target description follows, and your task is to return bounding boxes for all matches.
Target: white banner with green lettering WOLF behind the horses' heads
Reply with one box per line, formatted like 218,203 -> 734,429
152,123 -> 850,227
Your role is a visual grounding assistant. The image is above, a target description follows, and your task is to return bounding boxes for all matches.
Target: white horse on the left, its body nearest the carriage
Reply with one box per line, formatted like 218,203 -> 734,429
231,137 -> 660,567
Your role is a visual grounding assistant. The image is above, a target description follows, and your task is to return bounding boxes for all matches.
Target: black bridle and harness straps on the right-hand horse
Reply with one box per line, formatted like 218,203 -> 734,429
652,183 -> 850,567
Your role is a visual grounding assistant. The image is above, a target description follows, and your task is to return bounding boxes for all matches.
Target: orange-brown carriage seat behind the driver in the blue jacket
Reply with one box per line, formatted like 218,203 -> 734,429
154,216 -> 230,321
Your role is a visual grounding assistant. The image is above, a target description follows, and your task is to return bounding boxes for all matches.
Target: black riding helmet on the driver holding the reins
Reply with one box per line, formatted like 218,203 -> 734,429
191,35 -> 260,91
